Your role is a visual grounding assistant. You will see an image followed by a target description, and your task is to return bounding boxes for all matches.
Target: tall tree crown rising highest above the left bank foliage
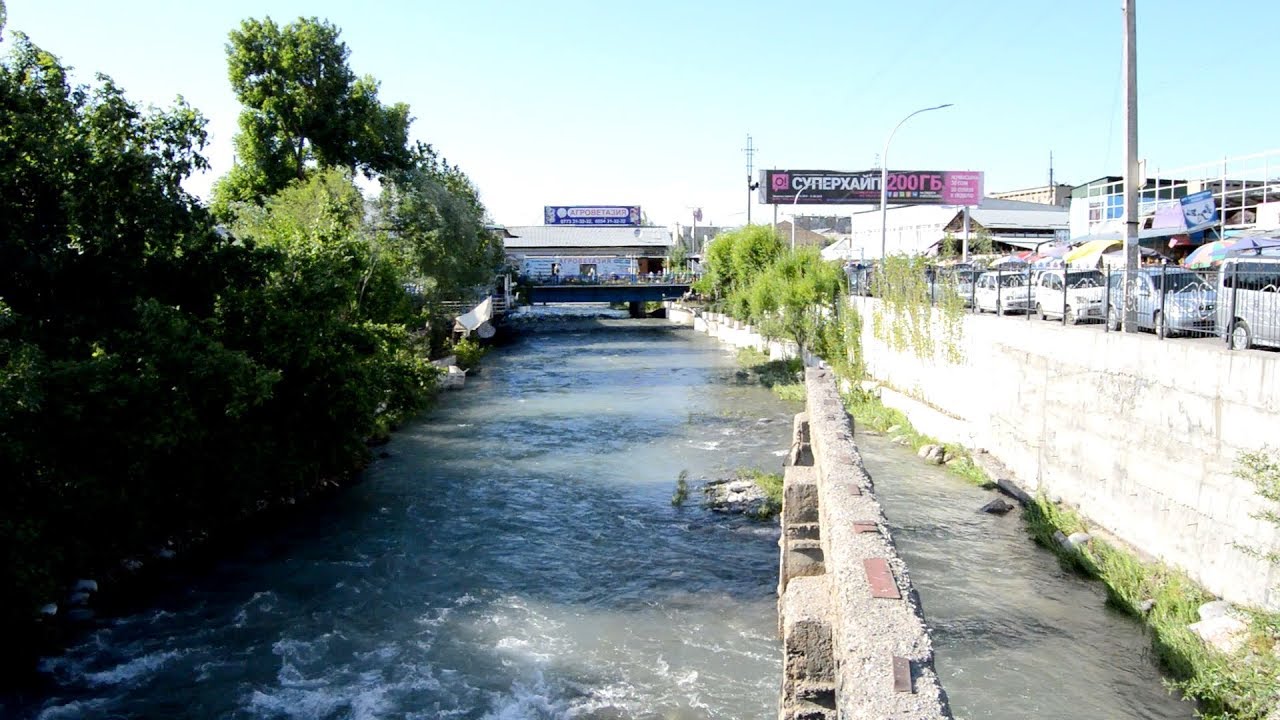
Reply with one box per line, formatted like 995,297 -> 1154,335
214,18 -> 411,214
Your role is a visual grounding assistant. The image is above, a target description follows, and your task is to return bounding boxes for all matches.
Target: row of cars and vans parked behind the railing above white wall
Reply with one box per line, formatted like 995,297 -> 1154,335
933,256 -> 1280,350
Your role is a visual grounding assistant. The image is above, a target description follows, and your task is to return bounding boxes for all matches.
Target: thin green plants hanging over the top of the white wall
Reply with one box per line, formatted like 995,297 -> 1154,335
872,255 -> 964,363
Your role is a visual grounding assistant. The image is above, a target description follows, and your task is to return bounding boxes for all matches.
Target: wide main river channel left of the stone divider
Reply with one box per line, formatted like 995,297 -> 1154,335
5,322 -> 796,719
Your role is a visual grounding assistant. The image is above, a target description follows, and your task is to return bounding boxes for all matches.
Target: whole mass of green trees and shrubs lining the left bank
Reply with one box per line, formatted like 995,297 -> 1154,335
0,12 -> 500,667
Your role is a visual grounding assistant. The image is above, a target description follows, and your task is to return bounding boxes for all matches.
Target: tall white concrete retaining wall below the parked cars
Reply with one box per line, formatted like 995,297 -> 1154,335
851,297 -> 1280,609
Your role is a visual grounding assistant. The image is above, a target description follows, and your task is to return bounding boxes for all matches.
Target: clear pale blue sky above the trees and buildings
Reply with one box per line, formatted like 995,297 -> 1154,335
0,0 -> 1280,224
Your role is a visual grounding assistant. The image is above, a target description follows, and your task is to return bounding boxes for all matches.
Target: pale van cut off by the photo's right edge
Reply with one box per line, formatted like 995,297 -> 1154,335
1217,255 -> 1280,350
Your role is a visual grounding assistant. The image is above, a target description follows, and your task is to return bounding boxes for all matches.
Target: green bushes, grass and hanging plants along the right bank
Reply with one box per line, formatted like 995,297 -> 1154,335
698,234 -> 1280,720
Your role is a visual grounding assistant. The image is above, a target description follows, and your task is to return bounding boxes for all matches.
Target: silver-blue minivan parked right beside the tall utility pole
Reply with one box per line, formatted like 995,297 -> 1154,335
1107,268 -> 1217,337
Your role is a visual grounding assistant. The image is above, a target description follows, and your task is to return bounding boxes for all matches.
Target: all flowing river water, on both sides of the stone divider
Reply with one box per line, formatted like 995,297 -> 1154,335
0,312 -> 1192,719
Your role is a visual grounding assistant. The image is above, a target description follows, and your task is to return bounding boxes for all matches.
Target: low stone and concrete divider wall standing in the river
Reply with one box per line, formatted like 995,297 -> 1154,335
778,368 -> 951,720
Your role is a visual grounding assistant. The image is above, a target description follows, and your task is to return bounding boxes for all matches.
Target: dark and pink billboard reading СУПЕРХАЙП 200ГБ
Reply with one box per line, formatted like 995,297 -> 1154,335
760,170 -> 982,205
